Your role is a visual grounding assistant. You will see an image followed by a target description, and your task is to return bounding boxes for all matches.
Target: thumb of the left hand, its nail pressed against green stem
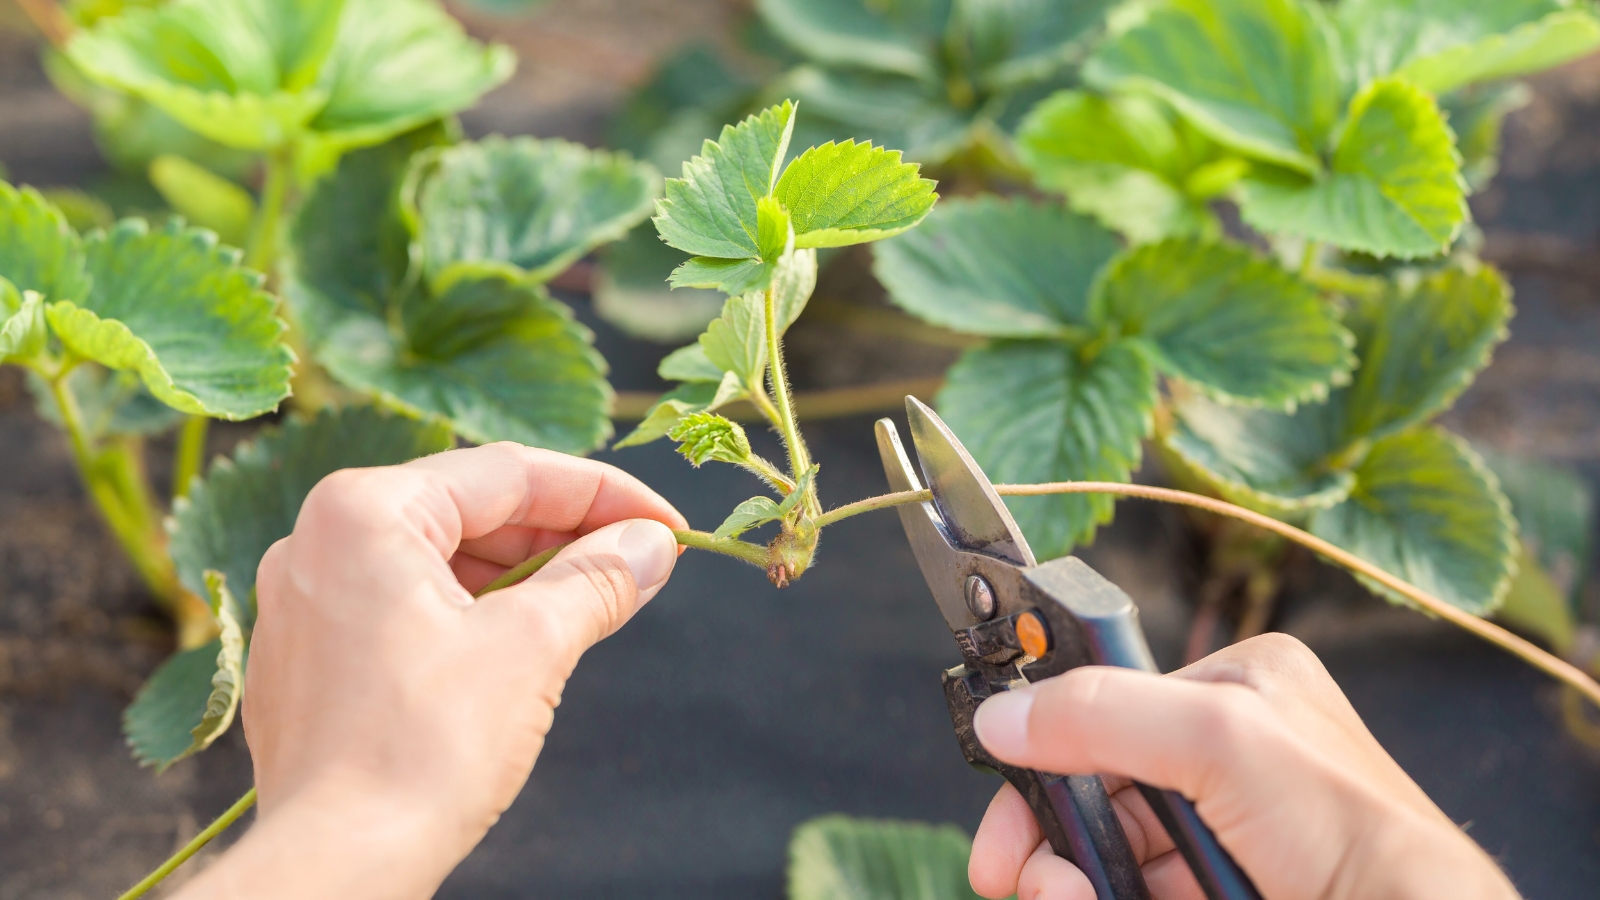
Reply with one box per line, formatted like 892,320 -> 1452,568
474,519 -> 678,665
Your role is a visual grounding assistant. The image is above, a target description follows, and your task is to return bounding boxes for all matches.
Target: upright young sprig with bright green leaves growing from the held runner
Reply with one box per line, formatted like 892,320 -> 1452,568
618,101 -> 938,583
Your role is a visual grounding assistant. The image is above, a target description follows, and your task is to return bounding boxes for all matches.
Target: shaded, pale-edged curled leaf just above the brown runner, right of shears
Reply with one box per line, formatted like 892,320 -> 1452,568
1162,389 -> 1355,519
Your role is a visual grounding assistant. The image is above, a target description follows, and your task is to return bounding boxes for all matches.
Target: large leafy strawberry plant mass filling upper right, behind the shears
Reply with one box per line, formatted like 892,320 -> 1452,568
877,0 -> 1600,615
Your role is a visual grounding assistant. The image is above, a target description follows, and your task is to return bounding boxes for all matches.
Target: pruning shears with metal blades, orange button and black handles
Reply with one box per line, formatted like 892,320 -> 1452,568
877,397 -> 1261,900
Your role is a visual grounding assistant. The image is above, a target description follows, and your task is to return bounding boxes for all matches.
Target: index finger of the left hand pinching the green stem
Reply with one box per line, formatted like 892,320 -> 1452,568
403,442 -> 688,552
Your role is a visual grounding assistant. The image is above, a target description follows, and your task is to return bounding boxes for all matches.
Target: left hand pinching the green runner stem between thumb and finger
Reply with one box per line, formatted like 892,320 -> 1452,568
182,444 -> 688,898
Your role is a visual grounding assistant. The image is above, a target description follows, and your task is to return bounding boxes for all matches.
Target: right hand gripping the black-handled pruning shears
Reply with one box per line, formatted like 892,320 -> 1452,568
968,634 -> 1517,900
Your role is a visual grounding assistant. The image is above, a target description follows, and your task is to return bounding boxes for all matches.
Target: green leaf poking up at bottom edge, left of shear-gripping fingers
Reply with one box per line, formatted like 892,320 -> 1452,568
789,815 -> 978,900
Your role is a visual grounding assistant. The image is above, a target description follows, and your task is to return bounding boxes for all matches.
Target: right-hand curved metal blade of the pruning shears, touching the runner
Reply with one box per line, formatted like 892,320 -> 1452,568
906,397 -> 1034,565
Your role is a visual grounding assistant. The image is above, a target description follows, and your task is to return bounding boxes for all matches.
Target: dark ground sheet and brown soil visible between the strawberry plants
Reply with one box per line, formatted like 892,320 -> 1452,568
0,0 -> 1600,900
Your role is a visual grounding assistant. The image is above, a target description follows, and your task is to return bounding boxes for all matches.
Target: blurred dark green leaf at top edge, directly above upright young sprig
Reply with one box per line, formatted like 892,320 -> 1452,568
755,0 -> 947,82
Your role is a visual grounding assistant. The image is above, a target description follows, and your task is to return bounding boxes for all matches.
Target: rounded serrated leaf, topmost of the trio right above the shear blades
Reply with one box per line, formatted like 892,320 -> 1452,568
1094,239 -> 1355,407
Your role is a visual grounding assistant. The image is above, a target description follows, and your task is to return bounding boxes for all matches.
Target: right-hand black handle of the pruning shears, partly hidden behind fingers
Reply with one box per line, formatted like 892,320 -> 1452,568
1075,595 -> 1261,900
